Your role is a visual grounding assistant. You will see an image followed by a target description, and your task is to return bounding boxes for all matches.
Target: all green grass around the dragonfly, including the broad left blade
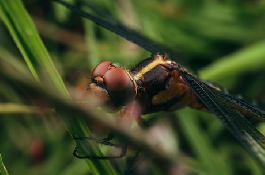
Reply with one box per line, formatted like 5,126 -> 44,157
0,0 -> 265,175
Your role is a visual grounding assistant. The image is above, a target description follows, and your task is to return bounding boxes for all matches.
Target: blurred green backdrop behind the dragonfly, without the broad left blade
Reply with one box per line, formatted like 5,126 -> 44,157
0,0 -> 265,175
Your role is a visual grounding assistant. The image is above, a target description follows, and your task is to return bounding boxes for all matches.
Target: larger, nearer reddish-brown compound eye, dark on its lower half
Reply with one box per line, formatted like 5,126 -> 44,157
104,68 -> 136,106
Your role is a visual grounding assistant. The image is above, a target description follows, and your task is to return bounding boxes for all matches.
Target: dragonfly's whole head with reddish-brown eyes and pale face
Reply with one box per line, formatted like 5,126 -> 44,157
88,61 -> 137,112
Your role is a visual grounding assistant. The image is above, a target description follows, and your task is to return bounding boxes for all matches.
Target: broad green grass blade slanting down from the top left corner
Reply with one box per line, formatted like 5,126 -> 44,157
0,0 -> 115,174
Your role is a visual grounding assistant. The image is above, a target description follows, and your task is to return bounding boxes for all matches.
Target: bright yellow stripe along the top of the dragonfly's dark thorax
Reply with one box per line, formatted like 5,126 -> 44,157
134,55 -> 171,80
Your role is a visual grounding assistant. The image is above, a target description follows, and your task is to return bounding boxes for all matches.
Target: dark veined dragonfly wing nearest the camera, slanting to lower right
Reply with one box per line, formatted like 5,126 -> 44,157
179,70 -> 265,168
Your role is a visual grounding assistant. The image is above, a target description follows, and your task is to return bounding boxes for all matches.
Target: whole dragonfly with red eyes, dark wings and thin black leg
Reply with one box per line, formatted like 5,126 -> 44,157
54,0 -> 265,169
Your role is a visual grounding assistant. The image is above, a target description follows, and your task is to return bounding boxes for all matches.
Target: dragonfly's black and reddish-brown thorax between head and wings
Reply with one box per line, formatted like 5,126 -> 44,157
131,56 -> 207,114
